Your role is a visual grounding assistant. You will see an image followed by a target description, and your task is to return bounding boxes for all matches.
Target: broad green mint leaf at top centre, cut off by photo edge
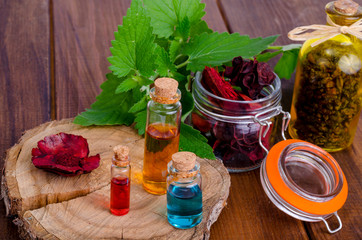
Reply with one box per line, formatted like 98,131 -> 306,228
144,0 -> 205,38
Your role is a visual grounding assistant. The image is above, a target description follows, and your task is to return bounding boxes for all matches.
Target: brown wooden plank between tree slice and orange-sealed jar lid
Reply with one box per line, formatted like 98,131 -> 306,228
210,172 -> 308,240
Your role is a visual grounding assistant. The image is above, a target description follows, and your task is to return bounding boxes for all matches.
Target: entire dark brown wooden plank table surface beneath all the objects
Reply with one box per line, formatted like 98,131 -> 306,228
0,0 -> 362,240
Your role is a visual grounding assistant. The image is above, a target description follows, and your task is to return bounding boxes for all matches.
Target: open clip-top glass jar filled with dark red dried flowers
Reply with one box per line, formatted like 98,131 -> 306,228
192,57 -> 282,172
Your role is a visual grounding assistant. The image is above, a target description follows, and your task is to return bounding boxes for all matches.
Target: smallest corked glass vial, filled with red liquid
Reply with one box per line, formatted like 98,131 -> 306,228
110,145 -> 131,216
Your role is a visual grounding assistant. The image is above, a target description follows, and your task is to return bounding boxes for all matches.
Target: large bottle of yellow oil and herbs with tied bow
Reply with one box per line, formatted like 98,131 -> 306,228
288,0 -> 362,152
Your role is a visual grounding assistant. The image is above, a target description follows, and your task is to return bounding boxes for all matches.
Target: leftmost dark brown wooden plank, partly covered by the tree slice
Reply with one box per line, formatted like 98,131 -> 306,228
0,0 -> 51,240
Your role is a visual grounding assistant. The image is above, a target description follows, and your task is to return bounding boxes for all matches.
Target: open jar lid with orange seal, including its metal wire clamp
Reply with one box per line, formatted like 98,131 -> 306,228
255,106 -> 348,233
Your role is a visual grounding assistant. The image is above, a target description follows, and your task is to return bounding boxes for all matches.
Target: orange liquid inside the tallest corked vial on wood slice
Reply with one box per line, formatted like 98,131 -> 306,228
143,123 -> 180,195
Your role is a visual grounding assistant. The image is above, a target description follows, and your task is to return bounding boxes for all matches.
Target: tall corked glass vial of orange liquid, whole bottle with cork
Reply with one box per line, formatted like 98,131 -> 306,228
143,78 -> 181,195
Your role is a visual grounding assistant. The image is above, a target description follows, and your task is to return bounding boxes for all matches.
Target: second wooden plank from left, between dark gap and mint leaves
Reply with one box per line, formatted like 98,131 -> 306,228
54,0 -> 131,119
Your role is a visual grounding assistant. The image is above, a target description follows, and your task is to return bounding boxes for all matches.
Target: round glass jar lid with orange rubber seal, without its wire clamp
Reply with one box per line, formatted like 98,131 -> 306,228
265,139 -> 348,215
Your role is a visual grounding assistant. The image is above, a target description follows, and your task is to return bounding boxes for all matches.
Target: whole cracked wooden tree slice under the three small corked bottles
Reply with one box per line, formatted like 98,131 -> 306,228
1,120 -> 230,239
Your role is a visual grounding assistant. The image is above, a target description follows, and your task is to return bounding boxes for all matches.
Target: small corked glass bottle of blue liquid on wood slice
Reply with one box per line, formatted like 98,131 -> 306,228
167,152 -> 202,229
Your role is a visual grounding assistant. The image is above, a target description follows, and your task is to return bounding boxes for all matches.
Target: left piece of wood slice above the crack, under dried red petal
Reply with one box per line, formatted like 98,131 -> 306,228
2,119 -> 143,215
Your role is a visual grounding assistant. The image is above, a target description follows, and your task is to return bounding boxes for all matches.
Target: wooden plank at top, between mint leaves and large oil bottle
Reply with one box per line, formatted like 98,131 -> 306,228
220,0 -> 330,44
